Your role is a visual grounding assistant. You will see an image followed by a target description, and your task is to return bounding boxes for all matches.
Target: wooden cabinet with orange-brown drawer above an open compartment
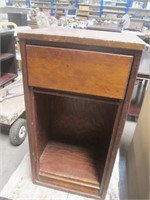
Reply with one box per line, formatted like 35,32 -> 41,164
20,28 -> 143,199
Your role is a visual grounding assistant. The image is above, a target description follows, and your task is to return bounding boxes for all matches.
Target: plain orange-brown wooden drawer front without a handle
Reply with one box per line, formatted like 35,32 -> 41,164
27,45 -> 133,99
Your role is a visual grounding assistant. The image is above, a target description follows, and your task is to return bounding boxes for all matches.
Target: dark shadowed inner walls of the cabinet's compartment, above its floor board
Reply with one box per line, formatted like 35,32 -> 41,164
34,93 -> 118,149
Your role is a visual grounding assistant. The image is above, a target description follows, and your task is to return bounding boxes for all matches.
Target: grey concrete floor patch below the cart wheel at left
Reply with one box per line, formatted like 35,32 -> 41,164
0,128 -> 28,191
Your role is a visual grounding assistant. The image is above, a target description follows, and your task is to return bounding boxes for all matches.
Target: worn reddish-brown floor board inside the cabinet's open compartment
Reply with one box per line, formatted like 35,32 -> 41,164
40,141 -> 104,189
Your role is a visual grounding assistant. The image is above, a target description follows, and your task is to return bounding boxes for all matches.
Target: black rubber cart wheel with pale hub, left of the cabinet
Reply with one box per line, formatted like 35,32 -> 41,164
9,118 -> 27,146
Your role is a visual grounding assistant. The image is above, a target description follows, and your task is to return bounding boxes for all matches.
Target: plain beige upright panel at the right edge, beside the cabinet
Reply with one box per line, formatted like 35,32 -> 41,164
127,84 -> 150,200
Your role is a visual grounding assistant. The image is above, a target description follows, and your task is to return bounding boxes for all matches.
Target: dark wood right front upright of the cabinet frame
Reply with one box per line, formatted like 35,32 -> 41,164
100,51 -> 142,199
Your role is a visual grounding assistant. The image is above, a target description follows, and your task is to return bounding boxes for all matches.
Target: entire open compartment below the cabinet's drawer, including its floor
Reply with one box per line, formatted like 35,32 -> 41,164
34,91 -> 118,197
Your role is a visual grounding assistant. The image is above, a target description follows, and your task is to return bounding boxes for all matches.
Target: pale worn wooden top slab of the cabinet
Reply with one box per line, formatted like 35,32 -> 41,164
18,27 -> 145,50
